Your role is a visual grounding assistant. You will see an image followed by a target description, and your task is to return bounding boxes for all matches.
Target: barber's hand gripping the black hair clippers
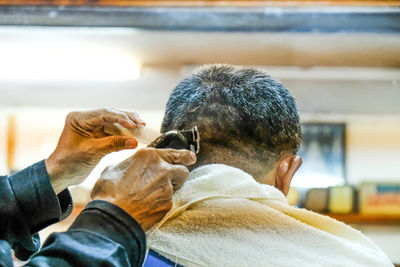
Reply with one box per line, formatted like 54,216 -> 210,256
92,148 -> 196,231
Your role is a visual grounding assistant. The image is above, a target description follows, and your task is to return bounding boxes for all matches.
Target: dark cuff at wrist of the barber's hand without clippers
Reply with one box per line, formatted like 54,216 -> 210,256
9,160 -> 72,234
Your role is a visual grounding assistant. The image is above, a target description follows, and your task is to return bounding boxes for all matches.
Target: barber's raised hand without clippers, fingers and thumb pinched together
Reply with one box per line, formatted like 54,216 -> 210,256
46,108 -> 145,193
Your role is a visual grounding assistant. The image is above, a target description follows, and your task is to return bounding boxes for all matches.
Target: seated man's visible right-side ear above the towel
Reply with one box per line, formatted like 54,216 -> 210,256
275,155 -> 303,196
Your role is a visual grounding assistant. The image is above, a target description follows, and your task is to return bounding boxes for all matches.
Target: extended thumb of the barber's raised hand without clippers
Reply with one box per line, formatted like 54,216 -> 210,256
94,135 -> 138,154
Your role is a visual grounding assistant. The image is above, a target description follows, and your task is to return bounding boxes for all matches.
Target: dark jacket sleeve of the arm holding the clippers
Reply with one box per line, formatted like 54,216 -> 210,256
27,200 -> 146,267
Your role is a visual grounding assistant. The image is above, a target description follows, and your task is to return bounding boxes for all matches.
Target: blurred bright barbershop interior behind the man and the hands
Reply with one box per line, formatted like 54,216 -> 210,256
0,0 -> 400,263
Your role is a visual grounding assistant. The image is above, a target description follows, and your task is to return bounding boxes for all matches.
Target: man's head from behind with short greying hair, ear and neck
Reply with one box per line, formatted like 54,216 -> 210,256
161,65 -> 301,193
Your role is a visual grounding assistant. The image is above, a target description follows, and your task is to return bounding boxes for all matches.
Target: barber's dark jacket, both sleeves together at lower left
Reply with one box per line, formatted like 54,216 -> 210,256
0,161 -> 146,266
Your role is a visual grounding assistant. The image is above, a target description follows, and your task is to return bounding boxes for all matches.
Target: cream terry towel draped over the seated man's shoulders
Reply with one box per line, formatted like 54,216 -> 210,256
148,164 -> 393,267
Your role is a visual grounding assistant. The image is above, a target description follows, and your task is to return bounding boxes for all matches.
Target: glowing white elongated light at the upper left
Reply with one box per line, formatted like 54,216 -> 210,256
0,41 -> 140,81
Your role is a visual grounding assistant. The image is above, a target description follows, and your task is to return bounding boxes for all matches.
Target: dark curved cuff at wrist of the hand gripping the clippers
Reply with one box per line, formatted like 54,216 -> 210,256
68,200 -> 146,266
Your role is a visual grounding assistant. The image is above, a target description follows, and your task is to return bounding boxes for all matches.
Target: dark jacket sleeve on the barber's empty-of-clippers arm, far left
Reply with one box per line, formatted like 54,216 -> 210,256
0,160 -> 72,260
